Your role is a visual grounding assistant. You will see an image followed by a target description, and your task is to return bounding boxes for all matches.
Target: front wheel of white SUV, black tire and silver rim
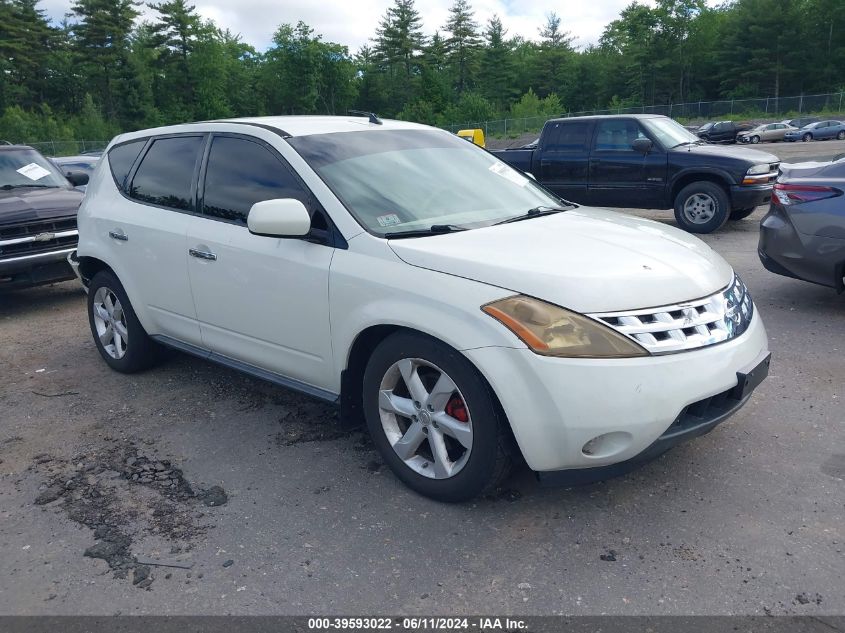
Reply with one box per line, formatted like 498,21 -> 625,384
363,332 -> 516,502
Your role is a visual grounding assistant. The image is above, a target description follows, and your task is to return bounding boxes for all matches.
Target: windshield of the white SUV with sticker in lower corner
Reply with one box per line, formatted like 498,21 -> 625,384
288,130 -> 566,236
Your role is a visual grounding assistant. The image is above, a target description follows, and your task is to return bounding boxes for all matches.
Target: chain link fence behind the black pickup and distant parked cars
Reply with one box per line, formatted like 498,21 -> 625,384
446,91 -> 845,138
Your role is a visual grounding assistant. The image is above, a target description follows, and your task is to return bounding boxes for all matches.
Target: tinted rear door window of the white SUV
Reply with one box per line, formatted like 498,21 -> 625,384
129,136 -> 203,211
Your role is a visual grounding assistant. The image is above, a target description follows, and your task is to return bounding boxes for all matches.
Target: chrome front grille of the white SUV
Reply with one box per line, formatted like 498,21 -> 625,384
588,275 -> 754,354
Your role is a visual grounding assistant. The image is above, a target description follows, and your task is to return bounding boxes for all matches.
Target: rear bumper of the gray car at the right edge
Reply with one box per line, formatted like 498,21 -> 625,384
757,203 -> 845,292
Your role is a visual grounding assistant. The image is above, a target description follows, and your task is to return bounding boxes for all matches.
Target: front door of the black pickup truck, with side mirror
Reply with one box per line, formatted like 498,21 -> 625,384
588,119 -> 667,208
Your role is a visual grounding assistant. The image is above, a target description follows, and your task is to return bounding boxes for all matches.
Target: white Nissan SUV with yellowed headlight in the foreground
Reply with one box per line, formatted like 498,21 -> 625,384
71,116 -> 769,500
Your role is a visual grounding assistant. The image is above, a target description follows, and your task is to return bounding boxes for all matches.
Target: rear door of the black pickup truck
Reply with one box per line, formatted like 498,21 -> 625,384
535,119 -> 593,203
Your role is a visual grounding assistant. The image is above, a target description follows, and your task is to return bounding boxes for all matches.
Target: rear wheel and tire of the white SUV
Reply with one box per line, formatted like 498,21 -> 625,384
88,270 -> 163,374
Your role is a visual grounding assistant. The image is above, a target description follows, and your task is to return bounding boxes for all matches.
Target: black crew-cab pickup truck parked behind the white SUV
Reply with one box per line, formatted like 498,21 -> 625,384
493,115 -> 779,233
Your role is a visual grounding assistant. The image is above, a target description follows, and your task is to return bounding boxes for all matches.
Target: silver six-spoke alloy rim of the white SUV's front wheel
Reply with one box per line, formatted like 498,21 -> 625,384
378,358 -> 472,479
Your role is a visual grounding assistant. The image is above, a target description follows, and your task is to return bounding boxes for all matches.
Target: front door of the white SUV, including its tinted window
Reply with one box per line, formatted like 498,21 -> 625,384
188,134 -> 334,388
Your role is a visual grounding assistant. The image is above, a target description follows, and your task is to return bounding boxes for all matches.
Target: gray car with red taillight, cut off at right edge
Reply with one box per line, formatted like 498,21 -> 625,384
757,158 -> 845,292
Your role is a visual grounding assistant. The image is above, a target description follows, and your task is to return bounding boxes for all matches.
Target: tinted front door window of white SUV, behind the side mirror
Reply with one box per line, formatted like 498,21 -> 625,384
202,136 -> 309,224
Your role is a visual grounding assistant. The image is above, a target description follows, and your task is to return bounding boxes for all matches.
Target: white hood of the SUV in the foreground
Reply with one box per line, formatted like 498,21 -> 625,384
389,207 -> 733,312
